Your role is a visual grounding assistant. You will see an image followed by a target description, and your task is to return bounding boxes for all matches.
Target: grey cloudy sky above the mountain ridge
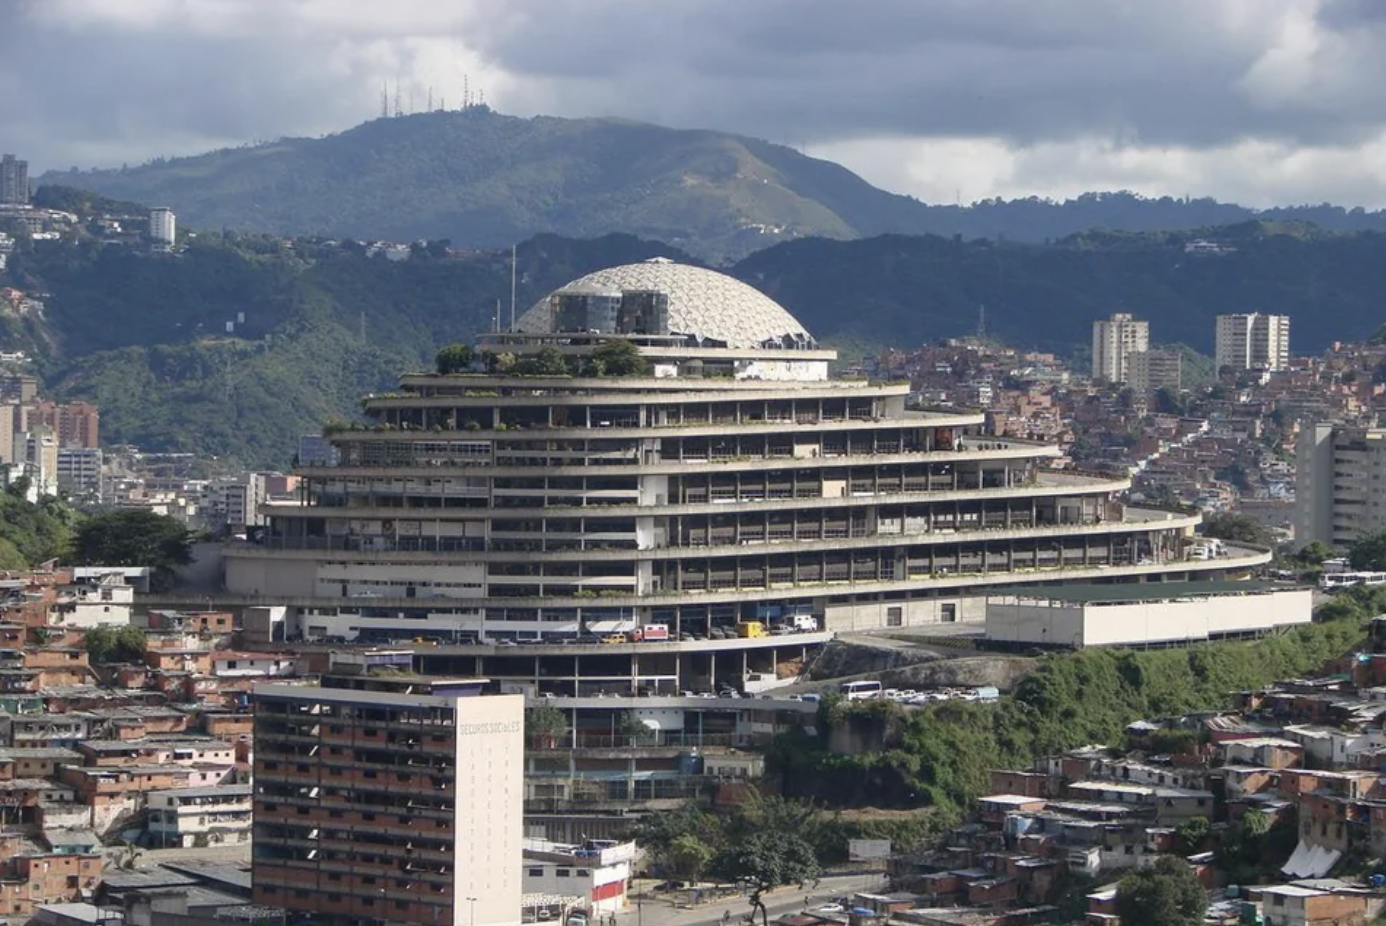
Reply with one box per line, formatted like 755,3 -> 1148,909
0,0 -> 1386,207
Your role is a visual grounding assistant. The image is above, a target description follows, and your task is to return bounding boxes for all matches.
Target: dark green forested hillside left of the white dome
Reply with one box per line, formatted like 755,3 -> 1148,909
0,236 -> 686,467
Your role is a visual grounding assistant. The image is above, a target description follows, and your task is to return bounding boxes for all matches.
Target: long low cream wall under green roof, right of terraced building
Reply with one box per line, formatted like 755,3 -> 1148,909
987,589 -> 1313,646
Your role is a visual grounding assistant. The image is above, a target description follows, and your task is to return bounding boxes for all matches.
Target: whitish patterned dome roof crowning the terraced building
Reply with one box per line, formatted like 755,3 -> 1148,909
516,258 -> 812,348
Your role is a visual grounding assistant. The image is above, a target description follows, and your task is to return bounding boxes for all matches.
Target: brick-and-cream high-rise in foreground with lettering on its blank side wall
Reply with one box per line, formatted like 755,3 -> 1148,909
252,674 -> 524,926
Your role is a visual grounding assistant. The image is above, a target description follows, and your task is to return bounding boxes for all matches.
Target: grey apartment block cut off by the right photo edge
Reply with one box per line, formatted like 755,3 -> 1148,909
1295,423 -> 1386,548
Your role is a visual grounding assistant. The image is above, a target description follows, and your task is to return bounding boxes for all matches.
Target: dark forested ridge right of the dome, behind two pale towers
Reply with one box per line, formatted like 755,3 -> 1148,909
732,223 -> 1386,354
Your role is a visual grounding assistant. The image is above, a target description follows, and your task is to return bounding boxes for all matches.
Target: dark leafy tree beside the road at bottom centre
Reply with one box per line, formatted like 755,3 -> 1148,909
710,792 -> 822,926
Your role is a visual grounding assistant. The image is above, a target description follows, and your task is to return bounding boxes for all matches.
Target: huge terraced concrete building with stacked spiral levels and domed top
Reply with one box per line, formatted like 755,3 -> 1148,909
218,256 -> 1268,640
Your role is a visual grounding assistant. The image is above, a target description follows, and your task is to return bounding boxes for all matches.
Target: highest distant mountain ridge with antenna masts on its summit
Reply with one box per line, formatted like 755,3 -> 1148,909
39,107 -> 1386,261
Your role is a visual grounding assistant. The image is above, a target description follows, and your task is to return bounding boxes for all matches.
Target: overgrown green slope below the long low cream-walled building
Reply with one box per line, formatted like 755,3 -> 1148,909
771,589 -> 1386,816
